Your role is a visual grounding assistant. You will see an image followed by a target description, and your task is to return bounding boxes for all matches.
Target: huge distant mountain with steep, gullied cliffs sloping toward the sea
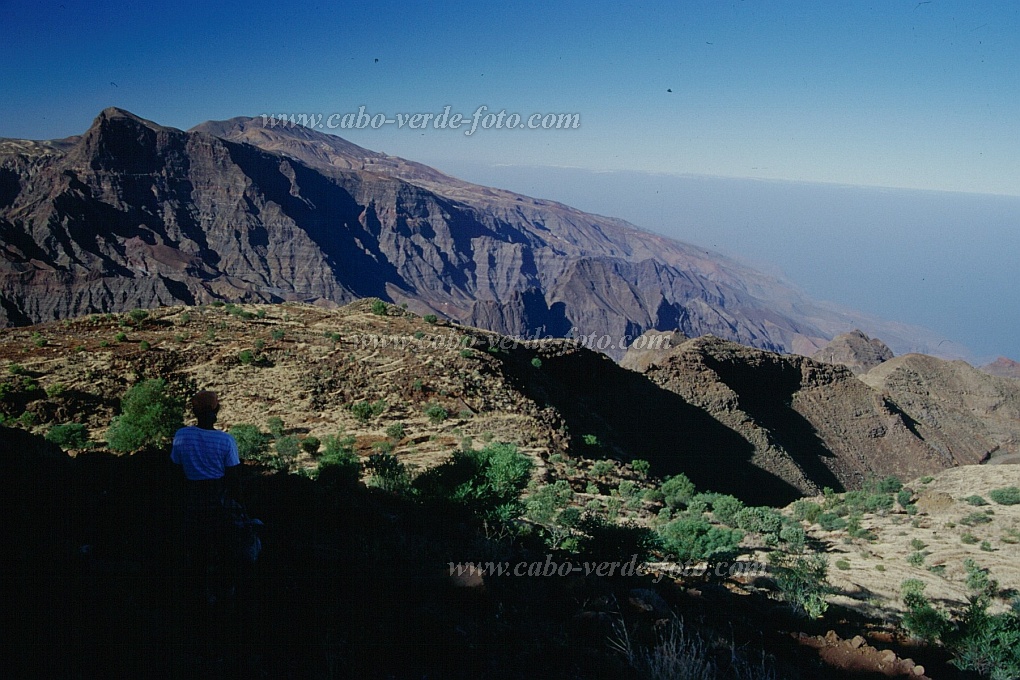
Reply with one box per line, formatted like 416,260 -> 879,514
0,109 -> 938,358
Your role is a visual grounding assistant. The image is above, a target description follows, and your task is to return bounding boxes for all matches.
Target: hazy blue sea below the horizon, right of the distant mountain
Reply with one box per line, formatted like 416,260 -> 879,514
430,160 -> 1020,364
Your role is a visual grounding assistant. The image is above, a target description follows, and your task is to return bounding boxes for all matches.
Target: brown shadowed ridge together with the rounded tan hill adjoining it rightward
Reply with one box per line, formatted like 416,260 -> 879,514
621,333 -> 1020,494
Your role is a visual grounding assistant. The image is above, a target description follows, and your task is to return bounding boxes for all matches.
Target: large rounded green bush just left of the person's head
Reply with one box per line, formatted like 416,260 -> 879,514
106,378 -> 184,453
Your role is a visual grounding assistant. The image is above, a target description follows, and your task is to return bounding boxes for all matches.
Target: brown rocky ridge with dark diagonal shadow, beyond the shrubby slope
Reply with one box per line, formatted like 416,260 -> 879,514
621,336 -> 962,493
